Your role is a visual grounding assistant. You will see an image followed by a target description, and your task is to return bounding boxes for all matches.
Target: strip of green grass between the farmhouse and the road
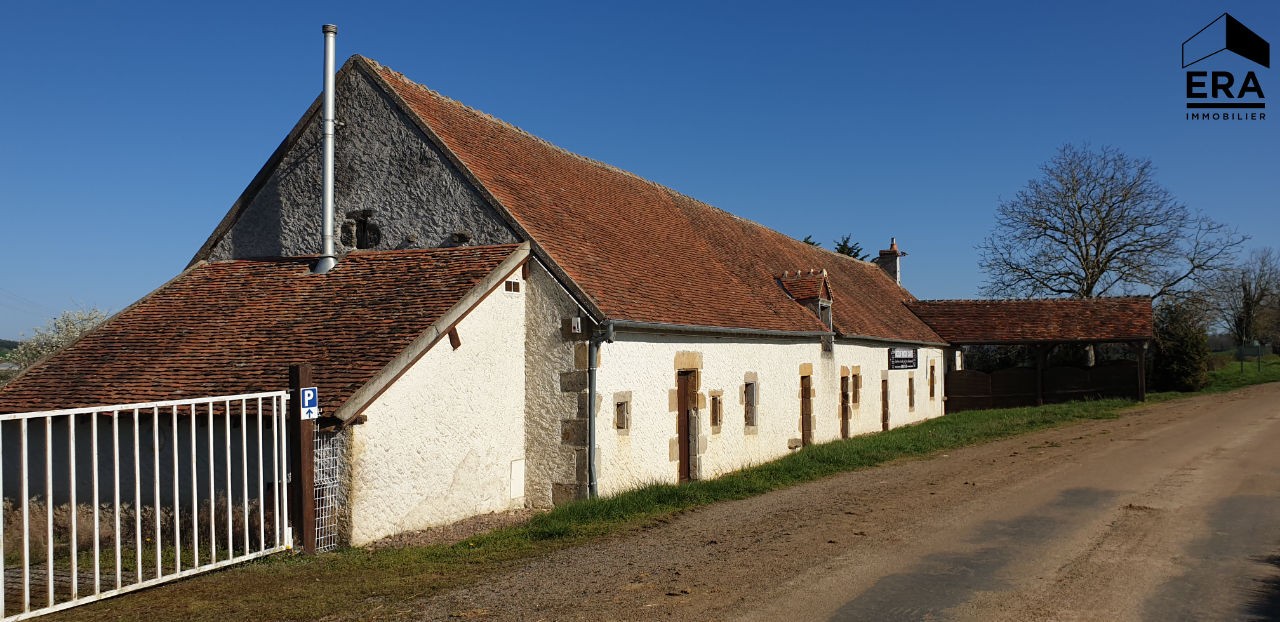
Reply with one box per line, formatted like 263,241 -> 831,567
63,357 -> 1280,621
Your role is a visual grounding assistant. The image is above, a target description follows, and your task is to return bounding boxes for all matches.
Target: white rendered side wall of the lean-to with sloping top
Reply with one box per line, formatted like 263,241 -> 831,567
349,271 -> 525,545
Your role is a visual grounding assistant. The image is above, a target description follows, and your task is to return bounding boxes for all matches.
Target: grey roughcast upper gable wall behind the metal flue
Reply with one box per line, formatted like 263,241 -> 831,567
209,63 -> 518,260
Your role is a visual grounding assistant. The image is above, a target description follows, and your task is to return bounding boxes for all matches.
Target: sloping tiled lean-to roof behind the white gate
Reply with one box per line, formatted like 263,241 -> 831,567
0,244 -> 517,413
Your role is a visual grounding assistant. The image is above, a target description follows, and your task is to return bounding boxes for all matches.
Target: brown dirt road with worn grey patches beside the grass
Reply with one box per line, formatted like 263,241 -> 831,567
363,384 -> 1280,622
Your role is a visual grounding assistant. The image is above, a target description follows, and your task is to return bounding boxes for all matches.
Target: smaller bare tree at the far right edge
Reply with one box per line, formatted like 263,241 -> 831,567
1208,248 -> 1280,346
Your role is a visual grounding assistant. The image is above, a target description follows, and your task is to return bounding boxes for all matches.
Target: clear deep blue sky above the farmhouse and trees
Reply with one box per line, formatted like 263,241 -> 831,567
0,0 -> 1280,338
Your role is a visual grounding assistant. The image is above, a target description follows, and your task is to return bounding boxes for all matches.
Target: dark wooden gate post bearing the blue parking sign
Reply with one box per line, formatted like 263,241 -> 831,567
289,363 -> 316,554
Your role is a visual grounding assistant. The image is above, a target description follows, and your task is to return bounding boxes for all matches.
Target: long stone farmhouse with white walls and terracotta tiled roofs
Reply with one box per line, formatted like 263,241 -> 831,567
0,56 -> 1149,544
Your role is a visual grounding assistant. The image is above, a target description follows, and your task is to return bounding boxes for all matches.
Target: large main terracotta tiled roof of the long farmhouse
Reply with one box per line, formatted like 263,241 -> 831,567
366,56 -> 941,343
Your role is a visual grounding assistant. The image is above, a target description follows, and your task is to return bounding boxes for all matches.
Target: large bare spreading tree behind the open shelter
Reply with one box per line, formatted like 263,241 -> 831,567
979,145 -> 1245,298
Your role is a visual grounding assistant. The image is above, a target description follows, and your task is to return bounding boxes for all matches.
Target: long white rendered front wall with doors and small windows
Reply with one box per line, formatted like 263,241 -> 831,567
596,333 -> 945,495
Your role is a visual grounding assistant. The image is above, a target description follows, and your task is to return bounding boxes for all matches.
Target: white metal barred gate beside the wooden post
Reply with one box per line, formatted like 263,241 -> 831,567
0,392 -> 293,621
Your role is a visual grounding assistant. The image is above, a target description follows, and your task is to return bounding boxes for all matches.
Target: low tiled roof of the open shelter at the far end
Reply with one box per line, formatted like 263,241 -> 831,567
908,297 -> 1152,344
